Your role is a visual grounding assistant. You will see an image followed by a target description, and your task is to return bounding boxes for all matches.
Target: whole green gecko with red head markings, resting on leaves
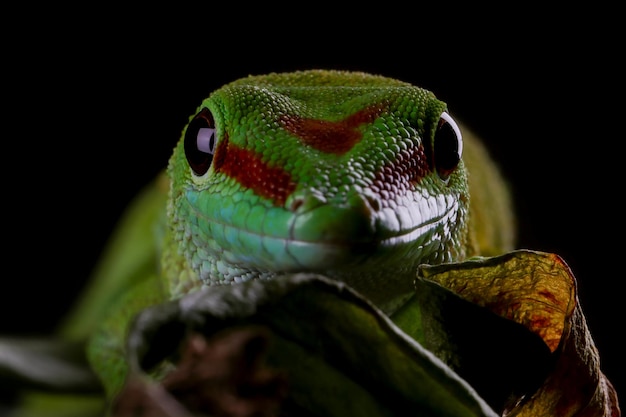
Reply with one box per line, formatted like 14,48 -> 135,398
62,70 -> 515,404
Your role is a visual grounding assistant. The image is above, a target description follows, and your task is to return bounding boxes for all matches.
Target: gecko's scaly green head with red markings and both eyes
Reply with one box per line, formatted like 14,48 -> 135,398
168,70 -> 468,302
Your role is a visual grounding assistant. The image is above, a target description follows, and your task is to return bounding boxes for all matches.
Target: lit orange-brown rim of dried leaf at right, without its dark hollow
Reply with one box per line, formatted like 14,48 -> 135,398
420,249 -> 621,417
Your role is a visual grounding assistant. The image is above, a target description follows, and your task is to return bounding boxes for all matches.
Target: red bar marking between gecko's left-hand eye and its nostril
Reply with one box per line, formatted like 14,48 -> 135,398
213,136 -> 296,206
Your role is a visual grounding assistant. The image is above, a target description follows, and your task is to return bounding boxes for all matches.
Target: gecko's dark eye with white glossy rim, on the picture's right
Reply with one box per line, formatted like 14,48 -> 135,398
433,112 -> 463,180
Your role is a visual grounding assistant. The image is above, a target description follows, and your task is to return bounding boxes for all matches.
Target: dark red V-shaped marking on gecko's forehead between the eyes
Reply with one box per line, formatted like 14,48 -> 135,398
280,106 -> 386,155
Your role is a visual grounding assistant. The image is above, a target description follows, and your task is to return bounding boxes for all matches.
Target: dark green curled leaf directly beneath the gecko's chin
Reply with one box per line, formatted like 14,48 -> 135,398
122,274 -> 496,417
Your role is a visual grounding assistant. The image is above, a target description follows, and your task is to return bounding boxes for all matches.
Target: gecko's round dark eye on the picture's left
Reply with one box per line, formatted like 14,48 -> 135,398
185,108 -> 216,175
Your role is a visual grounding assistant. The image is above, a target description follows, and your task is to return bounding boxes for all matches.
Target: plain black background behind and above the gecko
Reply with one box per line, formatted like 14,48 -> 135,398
0,4 -> 626,404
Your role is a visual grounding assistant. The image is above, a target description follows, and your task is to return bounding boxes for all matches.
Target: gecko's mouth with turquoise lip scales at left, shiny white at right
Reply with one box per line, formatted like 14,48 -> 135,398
188,190 -> 458,272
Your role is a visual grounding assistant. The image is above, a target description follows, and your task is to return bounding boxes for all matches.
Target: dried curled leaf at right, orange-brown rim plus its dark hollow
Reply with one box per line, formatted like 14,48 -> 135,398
416,250 -> 621,417
